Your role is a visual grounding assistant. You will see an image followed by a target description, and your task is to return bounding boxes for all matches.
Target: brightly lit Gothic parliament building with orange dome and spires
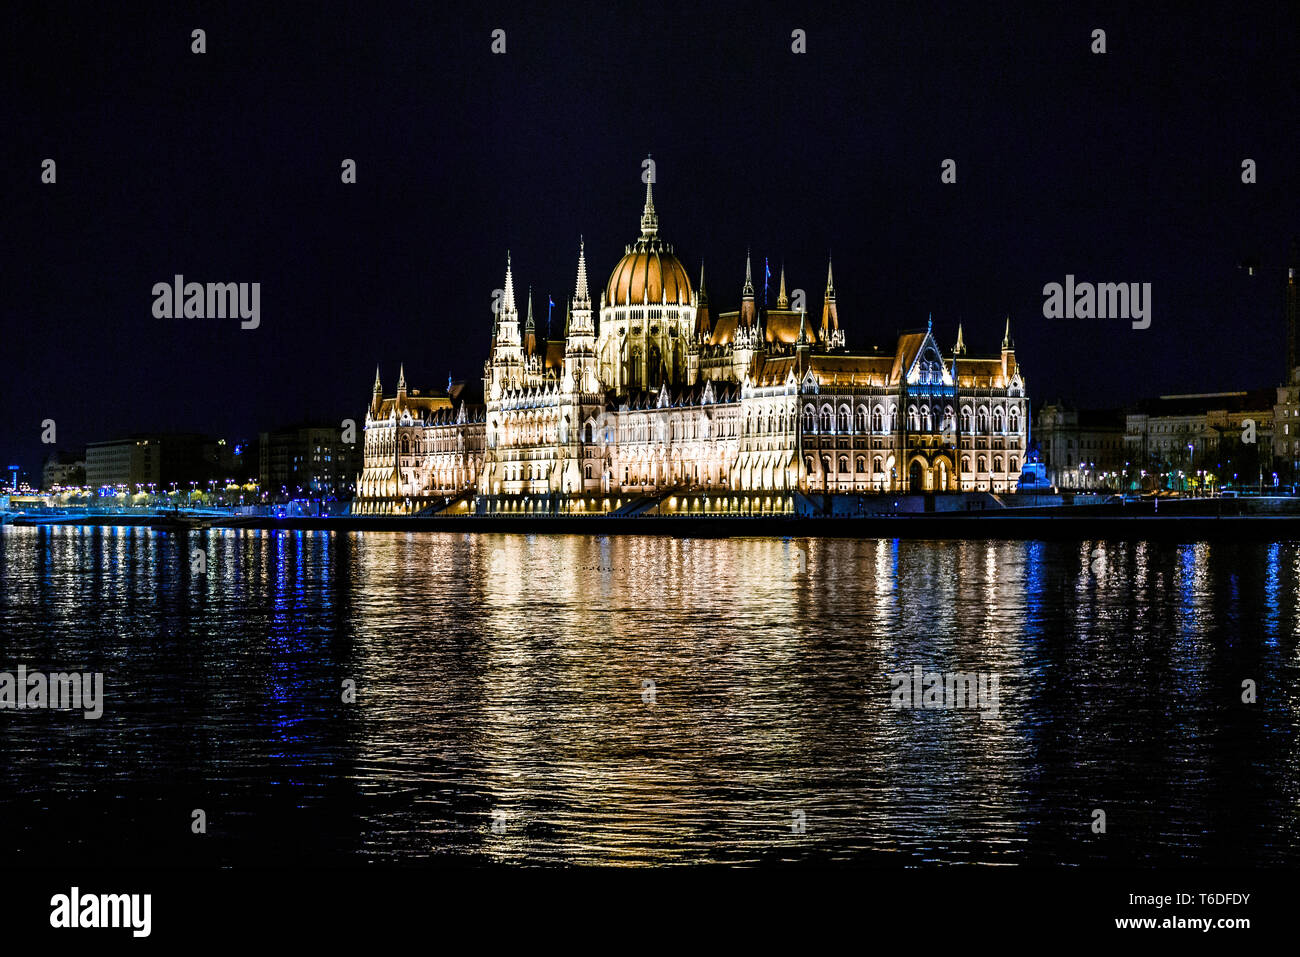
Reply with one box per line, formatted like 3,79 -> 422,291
352,174 -> 1030,515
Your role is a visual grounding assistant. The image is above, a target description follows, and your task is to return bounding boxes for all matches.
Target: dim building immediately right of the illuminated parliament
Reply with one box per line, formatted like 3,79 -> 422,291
1034,404 -> 1127,489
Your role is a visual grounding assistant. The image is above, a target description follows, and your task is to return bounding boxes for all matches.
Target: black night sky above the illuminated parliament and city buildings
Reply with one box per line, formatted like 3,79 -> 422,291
0,3 -> 1300,468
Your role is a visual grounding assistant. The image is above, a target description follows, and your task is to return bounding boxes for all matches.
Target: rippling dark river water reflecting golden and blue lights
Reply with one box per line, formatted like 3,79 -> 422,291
0,527 -> 1300,866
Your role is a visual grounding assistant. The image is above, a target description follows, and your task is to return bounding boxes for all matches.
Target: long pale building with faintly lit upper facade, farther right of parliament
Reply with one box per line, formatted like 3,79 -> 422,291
1125,389 -> 1277,489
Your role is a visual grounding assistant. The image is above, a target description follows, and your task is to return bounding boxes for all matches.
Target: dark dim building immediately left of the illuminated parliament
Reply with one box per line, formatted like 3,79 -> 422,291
259,424 -> 361,498
